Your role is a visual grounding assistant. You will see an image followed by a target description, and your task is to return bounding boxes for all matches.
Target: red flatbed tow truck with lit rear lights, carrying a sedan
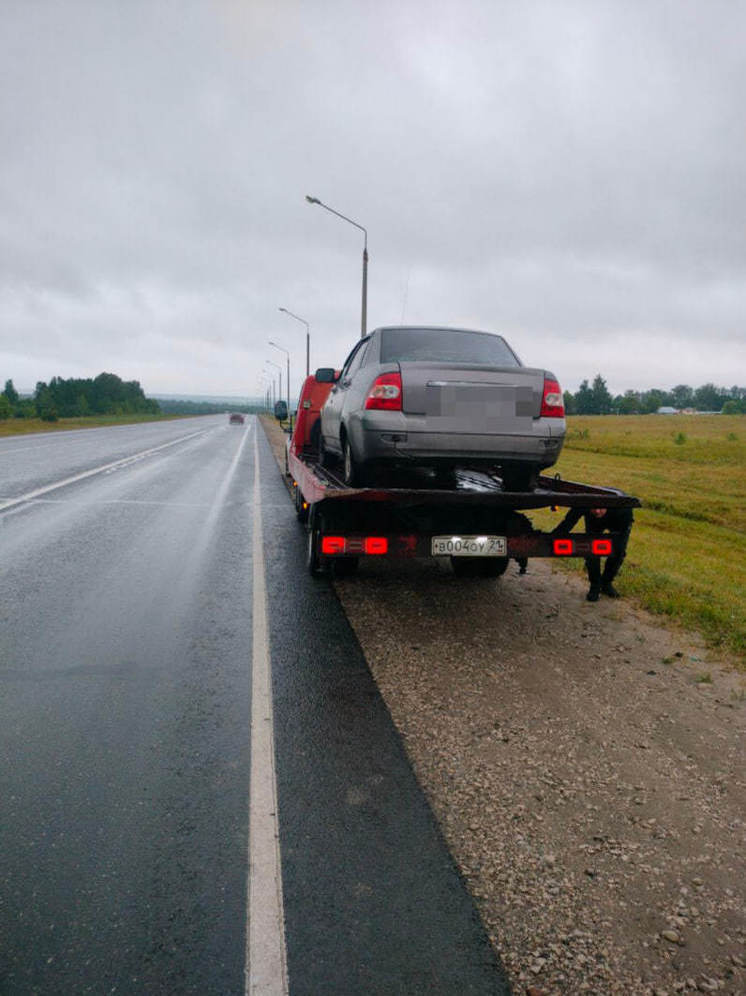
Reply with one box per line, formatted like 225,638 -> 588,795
286,375 -> 640,577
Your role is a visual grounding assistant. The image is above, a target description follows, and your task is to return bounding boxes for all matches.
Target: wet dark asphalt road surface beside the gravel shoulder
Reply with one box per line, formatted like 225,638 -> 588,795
0,417 -> 507,994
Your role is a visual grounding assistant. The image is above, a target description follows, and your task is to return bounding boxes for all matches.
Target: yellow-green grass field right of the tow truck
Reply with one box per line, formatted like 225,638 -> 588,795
536,415 -> 746,669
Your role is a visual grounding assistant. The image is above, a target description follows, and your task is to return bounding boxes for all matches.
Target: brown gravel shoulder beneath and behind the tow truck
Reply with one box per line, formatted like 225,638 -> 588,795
264,422 -> 746,996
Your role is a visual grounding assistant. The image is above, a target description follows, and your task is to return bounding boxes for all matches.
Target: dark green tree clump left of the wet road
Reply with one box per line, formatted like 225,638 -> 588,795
0,373 -> 160,422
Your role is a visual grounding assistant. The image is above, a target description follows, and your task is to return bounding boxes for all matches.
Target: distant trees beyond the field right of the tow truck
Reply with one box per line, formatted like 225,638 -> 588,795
564,374 -> 746,415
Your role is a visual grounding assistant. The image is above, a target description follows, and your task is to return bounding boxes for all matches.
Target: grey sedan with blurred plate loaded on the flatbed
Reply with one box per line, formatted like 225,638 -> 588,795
320,326 -> 565,491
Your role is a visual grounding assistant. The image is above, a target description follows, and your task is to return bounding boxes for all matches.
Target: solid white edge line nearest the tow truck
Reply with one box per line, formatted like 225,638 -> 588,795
245,434 -> 288,996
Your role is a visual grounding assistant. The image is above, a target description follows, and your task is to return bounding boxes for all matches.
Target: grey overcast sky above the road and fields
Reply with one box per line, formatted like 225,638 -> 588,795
0,0 -> 746,395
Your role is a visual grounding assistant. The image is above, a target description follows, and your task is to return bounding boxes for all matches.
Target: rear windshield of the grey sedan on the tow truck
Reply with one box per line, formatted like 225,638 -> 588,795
381,329 -> 521,367
